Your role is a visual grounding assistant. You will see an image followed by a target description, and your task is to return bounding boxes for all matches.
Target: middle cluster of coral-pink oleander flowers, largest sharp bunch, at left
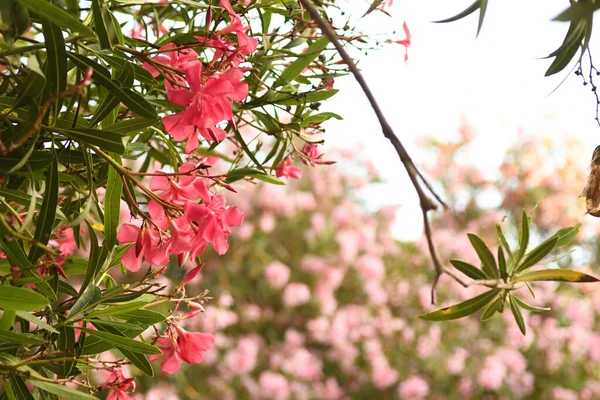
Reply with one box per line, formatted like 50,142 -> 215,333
117,161 -> 244,271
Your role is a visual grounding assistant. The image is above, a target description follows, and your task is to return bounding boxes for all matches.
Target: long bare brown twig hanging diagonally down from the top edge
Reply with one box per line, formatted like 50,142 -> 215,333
298,0 -> 446,303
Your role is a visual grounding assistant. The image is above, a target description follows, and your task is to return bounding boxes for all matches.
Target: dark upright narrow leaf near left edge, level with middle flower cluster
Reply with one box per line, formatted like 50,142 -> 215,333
29,158 -> 58,264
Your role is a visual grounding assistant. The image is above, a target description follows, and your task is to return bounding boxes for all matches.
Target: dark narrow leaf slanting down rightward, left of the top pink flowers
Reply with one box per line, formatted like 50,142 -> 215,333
67,52 -> 158,119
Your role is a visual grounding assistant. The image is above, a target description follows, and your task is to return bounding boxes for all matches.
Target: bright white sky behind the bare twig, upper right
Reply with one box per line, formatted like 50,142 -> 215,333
327,0 -> 600,239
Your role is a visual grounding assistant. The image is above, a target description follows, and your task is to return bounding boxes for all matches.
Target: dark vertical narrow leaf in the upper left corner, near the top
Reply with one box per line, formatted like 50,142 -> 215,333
42,19 -> 67,101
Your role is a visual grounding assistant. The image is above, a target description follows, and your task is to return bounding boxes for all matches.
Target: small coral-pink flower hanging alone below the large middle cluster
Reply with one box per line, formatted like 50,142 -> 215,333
149,326 -> 215,374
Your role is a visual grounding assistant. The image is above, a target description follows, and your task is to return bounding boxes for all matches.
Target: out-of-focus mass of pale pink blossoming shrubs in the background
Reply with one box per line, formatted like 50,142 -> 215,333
134,132 -> 600,400
